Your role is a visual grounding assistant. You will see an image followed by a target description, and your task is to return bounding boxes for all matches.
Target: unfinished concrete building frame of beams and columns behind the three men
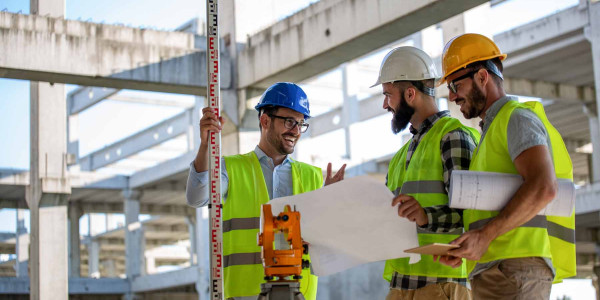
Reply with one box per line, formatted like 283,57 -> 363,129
0,0 -> 600,299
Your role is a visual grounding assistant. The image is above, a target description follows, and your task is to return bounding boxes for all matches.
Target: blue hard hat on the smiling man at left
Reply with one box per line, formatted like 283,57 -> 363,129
254,82 -> 310,119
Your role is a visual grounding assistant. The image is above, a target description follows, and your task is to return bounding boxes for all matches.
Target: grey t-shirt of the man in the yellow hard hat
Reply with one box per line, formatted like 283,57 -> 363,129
469,96 -> 556,280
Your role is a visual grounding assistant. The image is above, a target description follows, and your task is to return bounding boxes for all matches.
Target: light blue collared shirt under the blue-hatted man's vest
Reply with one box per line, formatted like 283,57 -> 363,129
186,146 -> 293,207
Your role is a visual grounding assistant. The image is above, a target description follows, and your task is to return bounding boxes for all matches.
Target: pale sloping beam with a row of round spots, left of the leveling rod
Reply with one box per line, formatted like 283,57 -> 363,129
79,109 -> 193,171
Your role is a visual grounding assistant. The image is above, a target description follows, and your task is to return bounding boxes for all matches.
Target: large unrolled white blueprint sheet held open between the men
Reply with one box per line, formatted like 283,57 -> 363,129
269,176 -> 420,276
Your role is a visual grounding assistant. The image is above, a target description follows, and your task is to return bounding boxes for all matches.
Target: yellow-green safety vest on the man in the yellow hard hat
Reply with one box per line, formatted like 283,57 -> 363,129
463,100 -> 576,283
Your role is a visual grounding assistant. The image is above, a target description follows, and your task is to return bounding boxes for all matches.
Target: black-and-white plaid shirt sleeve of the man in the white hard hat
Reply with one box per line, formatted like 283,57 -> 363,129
422,129 -> 476,233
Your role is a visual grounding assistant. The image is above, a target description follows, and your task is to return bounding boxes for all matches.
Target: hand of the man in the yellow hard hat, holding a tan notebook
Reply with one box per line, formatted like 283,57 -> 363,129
448,229 -> 493,261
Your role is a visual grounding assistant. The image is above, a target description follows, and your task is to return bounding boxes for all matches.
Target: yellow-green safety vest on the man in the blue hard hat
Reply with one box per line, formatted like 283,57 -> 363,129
223,152 -> 323,300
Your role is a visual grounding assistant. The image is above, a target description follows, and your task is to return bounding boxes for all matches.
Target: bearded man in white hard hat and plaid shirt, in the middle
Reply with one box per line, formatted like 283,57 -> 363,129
373,47 -> 479,300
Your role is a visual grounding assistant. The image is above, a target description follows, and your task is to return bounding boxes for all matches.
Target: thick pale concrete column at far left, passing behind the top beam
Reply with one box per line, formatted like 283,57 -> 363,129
26,0 -> 71,300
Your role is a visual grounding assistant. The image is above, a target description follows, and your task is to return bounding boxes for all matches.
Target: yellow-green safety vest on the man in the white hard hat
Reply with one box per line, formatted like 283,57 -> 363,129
383,117 -> 479,280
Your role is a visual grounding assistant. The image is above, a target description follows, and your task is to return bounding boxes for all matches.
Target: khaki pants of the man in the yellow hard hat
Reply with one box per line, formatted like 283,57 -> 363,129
471,257 -> 554,300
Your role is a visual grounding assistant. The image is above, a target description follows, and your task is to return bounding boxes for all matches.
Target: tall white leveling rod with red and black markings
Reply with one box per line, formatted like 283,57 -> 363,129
206,0 -> 224,300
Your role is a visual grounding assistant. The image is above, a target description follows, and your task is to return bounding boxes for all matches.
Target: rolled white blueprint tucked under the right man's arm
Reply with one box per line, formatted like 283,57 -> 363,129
449,170 -> 575,217
